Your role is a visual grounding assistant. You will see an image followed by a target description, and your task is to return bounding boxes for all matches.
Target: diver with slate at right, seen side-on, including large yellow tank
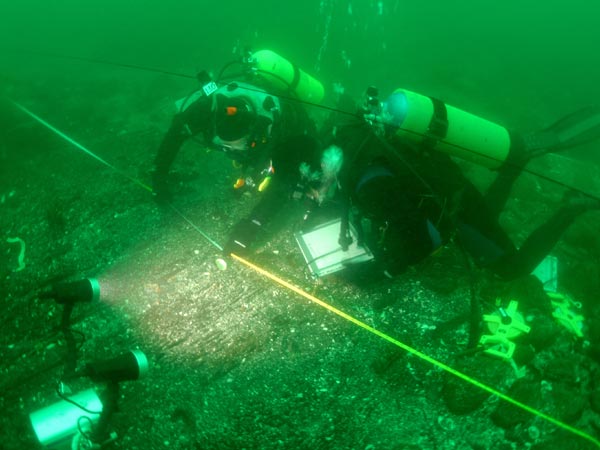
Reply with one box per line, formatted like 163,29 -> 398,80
318,88 -> 600,280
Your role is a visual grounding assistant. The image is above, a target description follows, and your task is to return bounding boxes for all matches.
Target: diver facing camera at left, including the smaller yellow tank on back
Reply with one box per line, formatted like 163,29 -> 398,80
152,50 -> 323,254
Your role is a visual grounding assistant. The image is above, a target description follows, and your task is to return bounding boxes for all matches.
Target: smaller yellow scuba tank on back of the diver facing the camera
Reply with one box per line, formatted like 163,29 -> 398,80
252,50 -> 325,103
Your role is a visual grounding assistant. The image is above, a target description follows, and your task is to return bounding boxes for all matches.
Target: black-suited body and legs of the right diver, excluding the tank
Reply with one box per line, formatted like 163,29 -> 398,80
326,89 -> 600,279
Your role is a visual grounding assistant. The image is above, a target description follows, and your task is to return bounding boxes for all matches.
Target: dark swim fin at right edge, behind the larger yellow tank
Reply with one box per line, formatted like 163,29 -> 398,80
523,107 -> 600,157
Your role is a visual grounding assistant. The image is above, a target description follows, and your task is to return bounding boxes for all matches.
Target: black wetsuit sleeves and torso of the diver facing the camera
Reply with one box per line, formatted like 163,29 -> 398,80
153,82 -> 319,253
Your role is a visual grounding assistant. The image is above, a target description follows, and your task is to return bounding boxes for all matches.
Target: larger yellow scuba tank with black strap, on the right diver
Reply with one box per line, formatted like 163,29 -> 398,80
384,89 -> 511,169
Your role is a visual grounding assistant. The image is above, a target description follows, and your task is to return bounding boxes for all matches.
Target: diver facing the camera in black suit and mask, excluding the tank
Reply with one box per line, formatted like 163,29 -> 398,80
152,73 -> 319,254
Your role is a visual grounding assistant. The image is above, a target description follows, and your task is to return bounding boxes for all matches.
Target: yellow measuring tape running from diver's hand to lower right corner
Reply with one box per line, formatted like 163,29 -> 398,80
231,253 -> 600,447
